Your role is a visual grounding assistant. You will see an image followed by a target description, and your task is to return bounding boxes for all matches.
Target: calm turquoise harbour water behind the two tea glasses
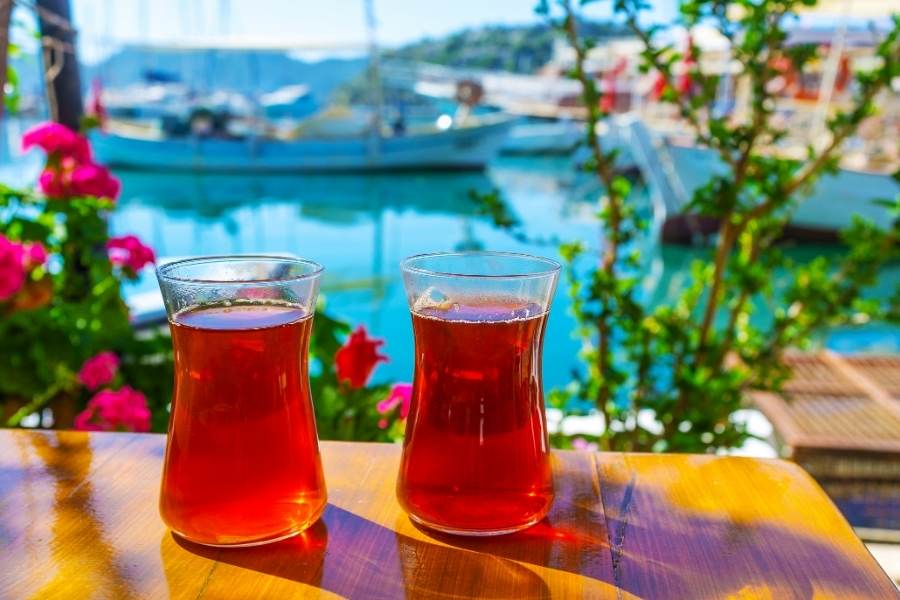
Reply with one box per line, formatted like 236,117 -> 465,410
111,159 -> 900,387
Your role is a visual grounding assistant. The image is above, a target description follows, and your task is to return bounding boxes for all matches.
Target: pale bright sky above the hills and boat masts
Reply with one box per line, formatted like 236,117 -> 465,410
61,0 -> 677,62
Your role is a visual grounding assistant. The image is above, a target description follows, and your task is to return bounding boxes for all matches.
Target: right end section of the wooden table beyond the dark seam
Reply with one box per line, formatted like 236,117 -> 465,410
601,455 -> 893,598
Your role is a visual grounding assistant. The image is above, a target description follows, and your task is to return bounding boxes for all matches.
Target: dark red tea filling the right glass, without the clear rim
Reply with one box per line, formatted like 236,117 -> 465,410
398,305 -> 553,533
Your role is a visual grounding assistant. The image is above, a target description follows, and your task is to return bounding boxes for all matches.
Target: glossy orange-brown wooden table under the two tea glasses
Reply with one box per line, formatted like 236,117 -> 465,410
0,430 -> 897,600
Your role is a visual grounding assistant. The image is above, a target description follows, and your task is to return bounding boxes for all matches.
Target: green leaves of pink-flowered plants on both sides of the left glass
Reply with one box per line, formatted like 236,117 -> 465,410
0,161 -> 403,441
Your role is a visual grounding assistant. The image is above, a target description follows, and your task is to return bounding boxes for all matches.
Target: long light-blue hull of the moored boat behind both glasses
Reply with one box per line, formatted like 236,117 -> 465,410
91,115 -> 513,173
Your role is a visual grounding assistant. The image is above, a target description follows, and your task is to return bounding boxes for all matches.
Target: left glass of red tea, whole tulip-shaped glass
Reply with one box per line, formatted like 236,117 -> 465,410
157,256 -> 326,546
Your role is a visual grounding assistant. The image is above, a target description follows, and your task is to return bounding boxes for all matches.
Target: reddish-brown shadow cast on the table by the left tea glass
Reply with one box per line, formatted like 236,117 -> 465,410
161,504 -> 550,599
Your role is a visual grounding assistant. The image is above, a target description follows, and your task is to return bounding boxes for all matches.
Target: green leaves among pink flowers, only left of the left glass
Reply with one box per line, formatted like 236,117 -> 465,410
0,186 -> 172,431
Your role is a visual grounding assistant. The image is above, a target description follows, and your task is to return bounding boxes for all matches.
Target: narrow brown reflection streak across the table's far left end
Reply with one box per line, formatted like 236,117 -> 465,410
29,432 -> 136,598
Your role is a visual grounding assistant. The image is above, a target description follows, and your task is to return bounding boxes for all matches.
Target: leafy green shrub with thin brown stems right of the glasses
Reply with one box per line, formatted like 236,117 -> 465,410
500,0 -> 900,452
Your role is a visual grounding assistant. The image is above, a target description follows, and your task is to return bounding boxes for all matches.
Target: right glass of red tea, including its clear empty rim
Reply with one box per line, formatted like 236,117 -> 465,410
397,252 -> 559,536
